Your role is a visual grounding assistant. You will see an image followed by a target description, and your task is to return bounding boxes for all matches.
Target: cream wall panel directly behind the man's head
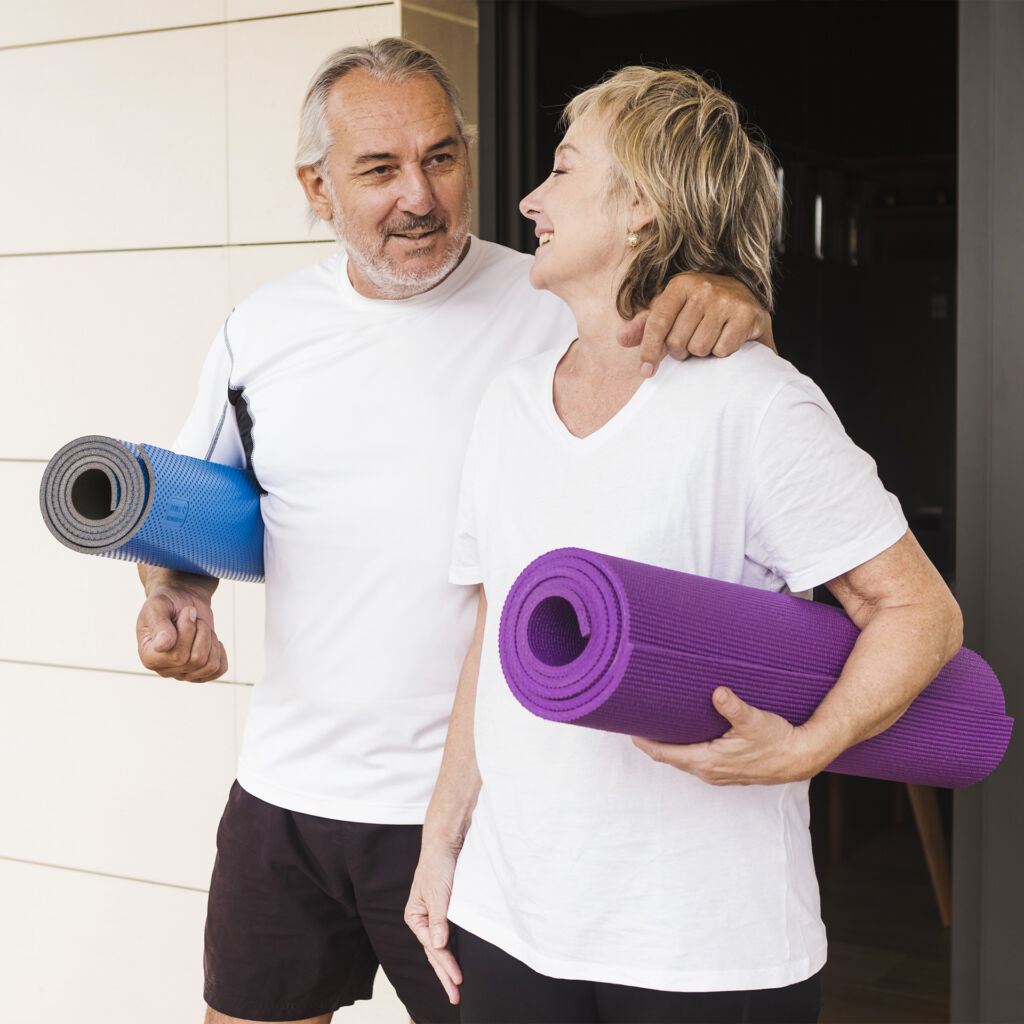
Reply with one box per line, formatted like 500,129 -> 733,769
227,4 -> 399,243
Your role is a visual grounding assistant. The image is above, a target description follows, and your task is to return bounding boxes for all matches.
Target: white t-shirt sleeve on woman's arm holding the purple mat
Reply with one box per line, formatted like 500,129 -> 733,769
746,378 -> 907,591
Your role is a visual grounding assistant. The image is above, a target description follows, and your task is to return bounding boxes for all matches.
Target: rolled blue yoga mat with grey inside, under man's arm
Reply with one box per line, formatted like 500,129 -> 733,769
39,434 -> 263,582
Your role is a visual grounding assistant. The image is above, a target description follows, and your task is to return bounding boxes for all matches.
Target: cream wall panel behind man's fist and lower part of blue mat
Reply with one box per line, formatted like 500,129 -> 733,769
0,462 -> 234,682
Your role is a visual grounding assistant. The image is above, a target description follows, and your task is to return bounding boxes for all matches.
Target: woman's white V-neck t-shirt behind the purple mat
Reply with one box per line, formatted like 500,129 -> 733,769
450,343 -> 906,991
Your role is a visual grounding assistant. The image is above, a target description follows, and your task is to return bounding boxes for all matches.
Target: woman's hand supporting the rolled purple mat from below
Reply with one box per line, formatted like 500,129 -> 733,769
633,686 -> 833,785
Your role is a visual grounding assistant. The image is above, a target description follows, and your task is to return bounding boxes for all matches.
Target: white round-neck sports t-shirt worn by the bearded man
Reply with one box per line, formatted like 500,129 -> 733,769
175,239 -> 575,824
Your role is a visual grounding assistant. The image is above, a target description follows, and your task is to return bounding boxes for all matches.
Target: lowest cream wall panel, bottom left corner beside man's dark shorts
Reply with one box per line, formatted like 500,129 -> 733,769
0,860 -> 206,1024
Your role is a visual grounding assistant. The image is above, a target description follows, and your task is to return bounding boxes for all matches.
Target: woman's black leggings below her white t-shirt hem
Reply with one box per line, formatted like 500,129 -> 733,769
453,926 -> 821,1024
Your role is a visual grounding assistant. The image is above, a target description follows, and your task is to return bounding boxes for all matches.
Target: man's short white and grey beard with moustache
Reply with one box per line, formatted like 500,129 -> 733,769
326,173 -> 470,299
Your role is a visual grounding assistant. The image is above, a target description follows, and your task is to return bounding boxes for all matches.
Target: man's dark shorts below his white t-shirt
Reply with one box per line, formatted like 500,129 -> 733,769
204,782 -> 459,1024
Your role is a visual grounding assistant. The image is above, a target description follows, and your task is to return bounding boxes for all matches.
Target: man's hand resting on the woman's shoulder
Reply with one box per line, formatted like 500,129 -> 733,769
618,273 -> 775,377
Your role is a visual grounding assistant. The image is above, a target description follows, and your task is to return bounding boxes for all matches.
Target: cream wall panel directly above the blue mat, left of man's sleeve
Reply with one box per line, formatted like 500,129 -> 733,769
0,249 -> 229,459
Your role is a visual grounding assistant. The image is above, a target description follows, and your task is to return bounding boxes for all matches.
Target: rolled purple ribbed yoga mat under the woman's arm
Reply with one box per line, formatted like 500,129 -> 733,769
499,548 -> 1013,786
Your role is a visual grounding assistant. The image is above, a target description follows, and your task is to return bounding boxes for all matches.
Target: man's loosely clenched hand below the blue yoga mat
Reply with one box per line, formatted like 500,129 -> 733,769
135,567 -> 227,683
